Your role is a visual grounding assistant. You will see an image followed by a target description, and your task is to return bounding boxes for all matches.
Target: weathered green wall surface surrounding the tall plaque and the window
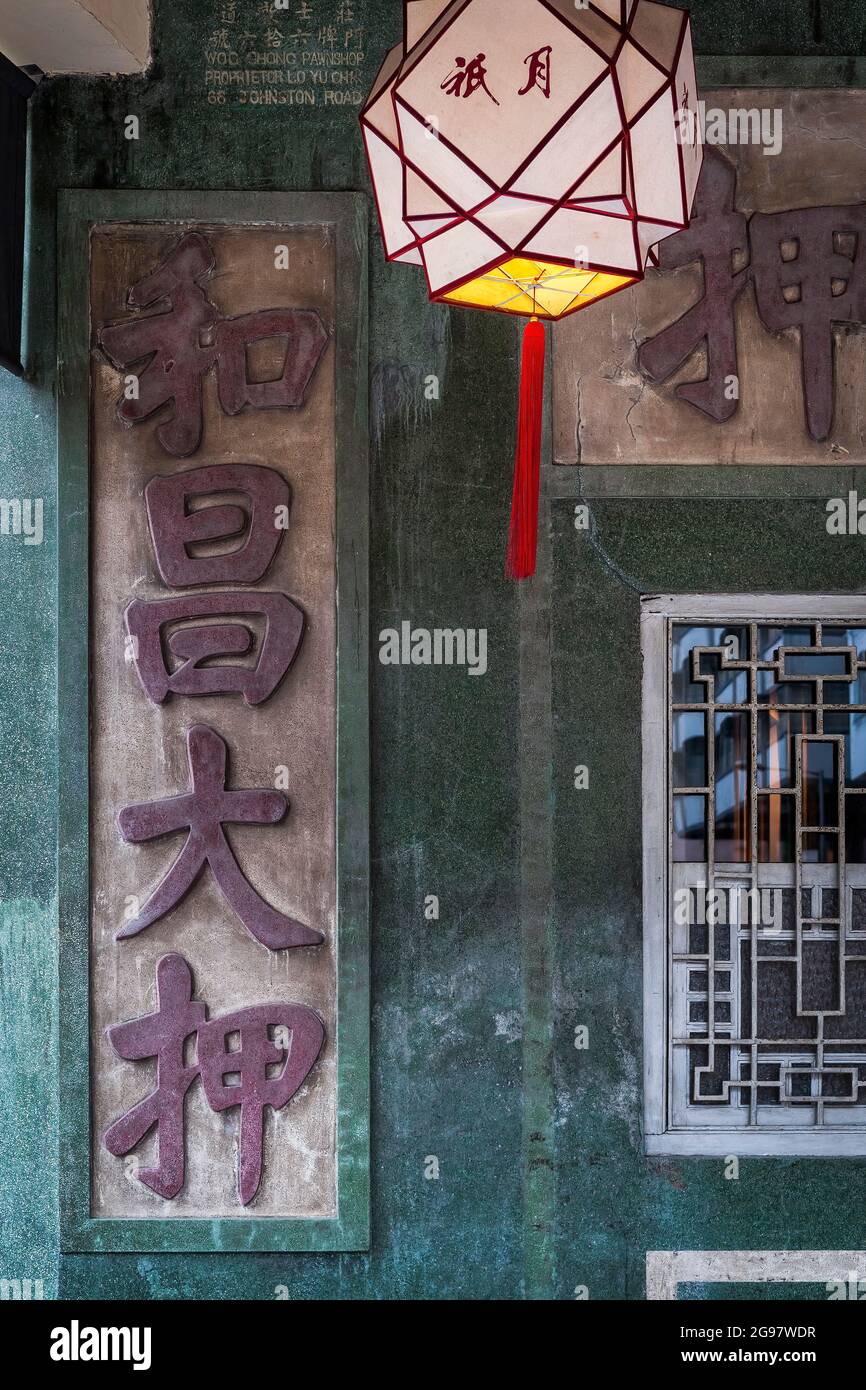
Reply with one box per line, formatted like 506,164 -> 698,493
0,0 -> 866,1298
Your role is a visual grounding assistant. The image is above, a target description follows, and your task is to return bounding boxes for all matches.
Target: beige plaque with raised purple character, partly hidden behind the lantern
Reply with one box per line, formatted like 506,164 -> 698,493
553,89 -> 866,466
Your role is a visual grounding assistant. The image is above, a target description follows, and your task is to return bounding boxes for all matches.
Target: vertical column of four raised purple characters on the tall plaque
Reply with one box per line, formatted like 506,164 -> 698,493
97,232 -> 328,1205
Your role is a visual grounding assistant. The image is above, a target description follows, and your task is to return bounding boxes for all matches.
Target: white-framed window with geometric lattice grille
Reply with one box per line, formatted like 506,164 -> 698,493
642,595 -> 866,1155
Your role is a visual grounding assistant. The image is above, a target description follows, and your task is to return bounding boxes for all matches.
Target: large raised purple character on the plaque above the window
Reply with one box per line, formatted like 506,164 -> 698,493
638,152 -> 866,441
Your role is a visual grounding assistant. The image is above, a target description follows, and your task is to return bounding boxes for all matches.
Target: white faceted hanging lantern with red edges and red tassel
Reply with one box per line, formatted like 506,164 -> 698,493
361,0 -> 702,578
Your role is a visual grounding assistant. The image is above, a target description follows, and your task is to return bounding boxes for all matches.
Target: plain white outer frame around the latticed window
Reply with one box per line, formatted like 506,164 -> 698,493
641,594 -> 866,1158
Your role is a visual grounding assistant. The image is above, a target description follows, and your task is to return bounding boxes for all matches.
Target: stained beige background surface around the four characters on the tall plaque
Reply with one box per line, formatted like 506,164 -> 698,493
90,225 -> 336,1219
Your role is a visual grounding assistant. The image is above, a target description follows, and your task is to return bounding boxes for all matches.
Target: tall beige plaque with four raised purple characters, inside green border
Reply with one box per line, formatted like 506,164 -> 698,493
80,222 -> 353,1222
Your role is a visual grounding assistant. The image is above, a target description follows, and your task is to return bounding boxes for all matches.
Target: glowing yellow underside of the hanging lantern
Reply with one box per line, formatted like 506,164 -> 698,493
439,256 -> 638,318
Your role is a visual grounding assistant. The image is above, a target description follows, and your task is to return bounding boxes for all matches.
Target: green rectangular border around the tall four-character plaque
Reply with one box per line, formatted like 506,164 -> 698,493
57,189 -> 370,1254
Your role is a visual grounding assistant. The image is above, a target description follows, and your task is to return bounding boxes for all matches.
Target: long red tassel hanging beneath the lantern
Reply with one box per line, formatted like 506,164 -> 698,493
505,318 -> 545,580
